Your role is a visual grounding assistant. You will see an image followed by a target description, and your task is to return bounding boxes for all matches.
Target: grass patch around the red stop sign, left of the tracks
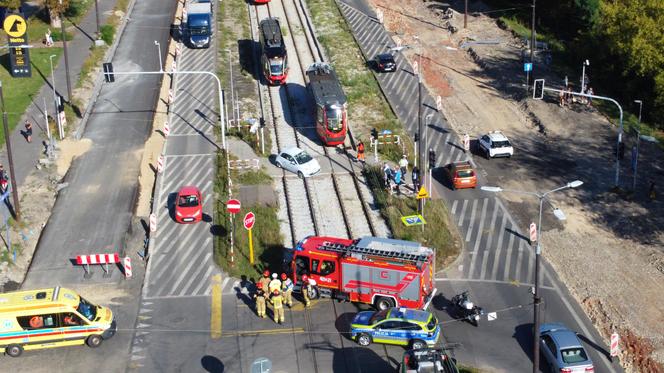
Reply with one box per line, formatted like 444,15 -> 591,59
214,152 -> 283,278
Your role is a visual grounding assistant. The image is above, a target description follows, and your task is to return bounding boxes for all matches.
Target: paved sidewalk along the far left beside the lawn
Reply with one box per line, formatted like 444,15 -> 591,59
0,0 -> 116,189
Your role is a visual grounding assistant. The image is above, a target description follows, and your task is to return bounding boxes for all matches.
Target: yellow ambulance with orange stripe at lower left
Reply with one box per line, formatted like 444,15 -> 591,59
0,286 -> 117,357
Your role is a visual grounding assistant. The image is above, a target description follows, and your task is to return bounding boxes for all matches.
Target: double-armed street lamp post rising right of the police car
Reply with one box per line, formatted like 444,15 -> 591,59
481,180 -> 583,373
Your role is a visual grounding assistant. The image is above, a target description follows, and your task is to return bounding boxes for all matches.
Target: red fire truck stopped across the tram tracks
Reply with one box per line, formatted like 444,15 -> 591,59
290,236 -> 436,310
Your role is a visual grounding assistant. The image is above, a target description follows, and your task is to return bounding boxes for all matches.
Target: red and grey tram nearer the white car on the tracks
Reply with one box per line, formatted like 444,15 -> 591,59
306,62 -> 348,146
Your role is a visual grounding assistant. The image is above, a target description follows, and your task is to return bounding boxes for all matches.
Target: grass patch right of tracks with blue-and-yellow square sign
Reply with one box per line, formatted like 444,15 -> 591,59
363,166 -> 461,268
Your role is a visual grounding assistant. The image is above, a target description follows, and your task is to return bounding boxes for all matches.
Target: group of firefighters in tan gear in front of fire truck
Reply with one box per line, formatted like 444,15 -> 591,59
254,270 -> 316,324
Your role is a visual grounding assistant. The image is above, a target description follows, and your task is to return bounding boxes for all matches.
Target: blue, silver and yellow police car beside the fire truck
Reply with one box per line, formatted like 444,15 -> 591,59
350,307 -> 440,349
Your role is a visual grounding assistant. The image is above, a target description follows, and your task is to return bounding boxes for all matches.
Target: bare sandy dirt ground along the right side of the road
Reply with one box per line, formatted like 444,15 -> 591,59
371,0 -> 664,372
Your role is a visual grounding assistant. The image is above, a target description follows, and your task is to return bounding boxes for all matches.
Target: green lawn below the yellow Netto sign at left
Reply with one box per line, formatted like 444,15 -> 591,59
0,47 -> 62,144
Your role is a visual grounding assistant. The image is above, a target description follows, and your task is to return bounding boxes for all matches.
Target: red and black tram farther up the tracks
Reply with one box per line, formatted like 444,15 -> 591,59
259,17 -> 288,85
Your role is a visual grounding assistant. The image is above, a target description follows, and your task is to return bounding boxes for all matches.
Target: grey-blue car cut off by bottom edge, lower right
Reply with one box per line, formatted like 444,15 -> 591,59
540,323 -> 595,373
